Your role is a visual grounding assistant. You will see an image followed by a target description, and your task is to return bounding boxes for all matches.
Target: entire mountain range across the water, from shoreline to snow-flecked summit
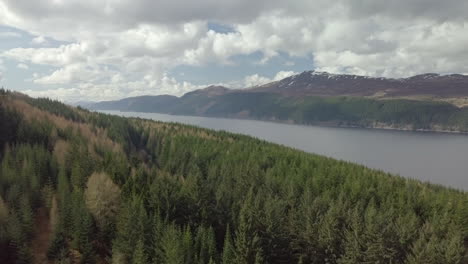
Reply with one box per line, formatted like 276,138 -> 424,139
88,71 -> 468,132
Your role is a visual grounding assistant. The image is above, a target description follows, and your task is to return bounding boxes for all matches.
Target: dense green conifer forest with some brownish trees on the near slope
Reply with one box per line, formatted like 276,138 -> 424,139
0,90 -> 468,264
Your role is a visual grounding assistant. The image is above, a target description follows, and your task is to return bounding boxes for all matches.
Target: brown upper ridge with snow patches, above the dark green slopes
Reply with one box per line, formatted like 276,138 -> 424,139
250,71 -> 468,97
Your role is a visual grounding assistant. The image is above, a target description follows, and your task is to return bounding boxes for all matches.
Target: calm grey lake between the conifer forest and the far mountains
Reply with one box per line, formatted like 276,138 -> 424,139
103,111 -> 468,190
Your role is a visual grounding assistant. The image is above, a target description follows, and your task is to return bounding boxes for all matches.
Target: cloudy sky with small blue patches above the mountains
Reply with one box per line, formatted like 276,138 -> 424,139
0,0 -> 468,102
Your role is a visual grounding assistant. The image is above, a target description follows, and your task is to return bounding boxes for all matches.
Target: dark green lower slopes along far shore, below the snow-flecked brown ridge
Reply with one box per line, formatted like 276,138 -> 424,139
87,90 -> 468,132
